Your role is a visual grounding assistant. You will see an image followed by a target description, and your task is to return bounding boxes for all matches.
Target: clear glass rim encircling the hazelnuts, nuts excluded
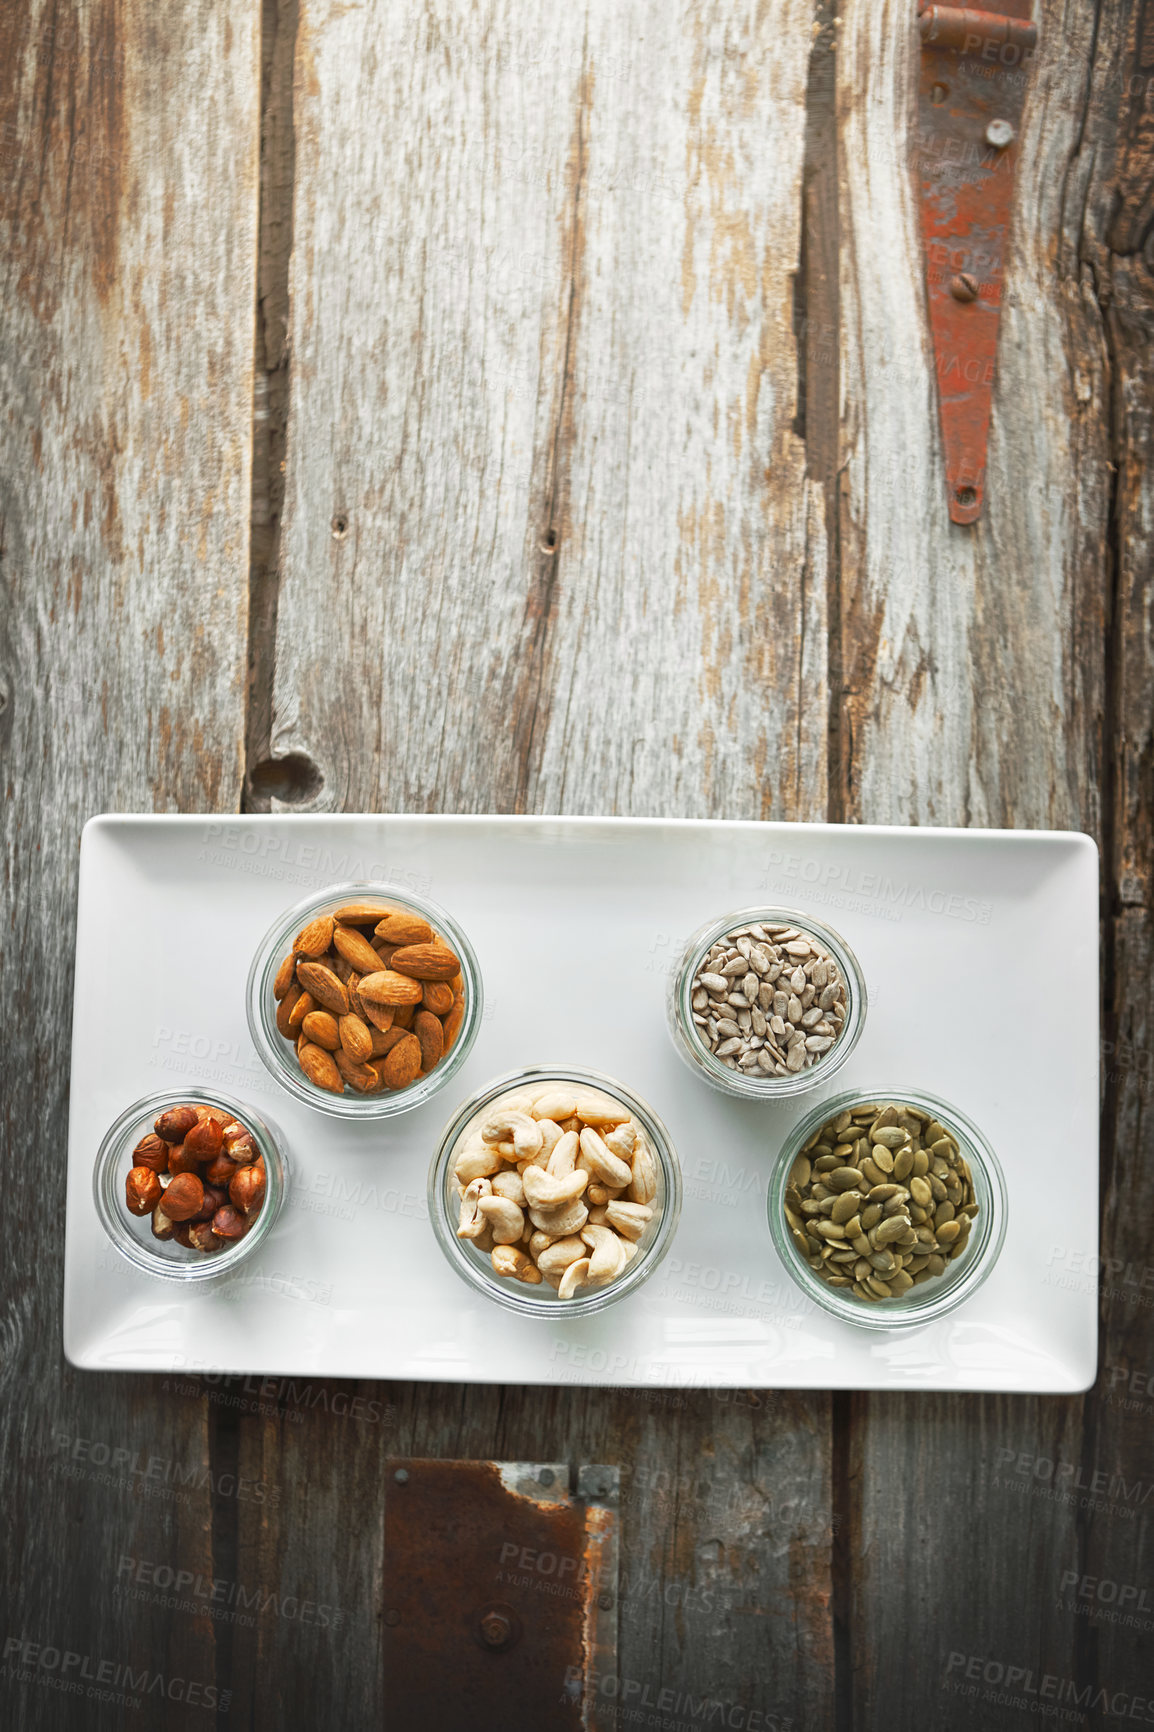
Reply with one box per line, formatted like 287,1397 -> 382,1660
92,1088 -> 289,1282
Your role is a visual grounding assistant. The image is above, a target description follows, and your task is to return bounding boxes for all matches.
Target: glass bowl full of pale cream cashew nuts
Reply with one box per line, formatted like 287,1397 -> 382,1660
428,1067 -> 681,1318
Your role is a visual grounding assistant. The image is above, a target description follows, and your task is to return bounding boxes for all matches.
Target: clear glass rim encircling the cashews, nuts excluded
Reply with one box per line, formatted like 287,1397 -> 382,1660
426,1065 -> 683,1323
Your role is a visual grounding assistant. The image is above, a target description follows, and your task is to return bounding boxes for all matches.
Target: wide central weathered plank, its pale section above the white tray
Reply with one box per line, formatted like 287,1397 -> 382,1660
272,0 -> 827,818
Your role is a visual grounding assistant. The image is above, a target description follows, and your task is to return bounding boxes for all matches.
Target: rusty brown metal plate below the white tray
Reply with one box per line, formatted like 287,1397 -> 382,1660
383,1458 -> 619,1732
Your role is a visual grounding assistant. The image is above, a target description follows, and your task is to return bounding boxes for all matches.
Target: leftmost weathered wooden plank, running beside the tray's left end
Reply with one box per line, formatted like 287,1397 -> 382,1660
0,0 -> 258,1727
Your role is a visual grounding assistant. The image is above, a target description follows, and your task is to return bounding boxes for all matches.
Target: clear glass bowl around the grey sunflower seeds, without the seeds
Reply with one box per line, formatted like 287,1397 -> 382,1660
667,908 -> 866,1100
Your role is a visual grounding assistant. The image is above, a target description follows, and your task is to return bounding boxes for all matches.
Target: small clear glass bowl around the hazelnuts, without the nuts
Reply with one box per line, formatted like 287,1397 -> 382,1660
92,1088 -> 288,1282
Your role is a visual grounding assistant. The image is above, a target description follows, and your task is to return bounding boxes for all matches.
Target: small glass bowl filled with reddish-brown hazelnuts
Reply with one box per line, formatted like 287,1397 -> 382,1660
94,1089 -> 288,1280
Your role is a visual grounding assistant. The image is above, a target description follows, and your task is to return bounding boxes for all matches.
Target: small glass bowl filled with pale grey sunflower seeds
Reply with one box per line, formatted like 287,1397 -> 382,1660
667,908 -> 866,1100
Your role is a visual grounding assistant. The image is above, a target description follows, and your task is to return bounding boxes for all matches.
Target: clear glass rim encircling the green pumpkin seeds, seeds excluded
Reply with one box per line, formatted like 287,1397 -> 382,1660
766,1084 -> 1008,1330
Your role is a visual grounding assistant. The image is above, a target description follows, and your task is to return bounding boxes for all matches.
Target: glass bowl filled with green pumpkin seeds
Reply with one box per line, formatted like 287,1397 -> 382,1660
769,1089 -> 1007,1328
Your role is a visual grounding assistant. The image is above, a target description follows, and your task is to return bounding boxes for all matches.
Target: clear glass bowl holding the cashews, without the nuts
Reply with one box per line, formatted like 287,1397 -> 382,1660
428,1065 -> 681,1323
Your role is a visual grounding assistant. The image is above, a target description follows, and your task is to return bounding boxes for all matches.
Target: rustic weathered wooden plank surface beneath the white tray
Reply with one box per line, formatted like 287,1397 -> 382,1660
0,0 -> 1154,1732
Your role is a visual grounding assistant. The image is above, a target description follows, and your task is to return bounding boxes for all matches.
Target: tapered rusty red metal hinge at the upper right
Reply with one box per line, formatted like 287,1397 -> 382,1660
918,0 -> 1038,523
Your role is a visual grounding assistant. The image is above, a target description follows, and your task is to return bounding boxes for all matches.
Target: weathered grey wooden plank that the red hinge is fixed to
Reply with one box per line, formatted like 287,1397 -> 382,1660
839,0 -> 1149,1729
